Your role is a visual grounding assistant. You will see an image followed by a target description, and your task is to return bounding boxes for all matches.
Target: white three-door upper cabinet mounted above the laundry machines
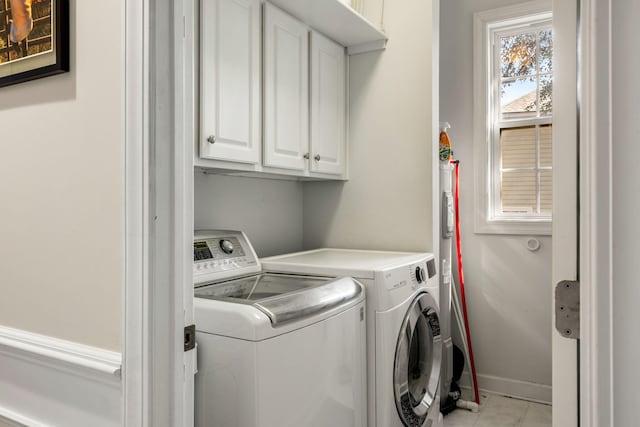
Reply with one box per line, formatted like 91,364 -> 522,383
199,0 -> 352,179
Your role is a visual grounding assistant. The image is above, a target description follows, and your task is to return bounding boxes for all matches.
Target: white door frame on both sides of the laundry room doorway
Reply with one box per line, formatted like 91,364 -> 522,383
122,0 -> 613,427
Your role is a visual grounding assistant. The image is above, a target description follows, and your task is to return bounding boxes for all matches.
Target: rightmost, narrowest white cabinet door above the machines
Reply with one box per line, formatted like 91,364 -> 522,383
310,31 -> 347,175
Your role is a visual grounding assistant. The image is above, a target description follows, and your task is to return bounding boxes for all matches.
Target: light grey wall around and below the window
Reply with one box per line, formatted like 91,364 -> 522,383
440,0 -> 551,401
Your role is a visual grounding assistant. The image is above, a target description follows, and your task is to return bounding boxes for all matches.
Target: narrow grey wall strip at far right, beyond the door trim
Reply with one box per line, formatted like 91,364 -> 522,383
608,1 -> 640,426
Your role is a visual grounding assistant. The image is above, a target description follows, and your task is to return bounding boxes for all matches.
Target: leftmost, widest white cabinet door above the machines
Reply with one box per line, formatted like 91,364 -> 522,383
200,0 -> 262,163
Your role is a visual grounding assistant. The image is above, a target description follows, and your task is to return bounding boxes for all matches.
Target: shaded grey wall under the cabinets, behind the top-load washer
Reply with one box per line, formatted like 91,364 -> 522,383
195,172 -> 303,257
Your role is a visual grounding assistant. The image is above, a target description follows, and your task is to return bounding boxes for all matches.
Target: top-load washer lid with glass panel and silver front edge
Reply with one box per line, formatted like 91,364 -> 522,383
195,273 -> 363,326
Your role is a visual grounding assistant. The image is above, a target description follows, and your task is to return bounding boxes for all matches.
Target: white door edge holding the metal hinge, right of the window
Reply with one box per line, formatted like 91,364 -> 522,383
552,1 -> 579,427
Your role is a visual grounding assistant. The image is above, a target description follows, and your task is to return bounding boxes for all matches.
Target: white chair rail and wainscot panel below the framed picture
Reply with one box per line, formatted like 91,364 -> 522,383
0,326 -> 122,427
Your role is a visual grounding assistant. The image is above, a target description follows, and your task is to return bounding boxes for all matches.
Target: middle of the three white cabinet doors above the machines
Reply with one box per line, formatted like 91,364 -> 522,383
264,3 -> 309,170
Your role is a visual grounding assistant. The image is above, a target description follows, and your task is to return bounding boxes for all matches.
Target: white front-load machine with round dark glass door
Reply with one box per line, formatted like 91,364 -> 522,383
261,249 -> 442,427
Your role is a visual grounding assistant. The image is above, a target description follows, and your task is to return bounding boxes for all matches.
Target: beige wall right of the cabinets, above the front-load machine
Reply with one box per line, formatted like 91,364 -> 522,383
304,0 -> 433,251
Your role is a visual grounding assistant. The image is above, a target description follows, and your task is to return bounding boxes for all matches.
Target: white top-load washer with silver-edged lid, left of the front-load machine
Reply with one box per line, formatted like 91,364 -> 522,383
194,231 -> 367,427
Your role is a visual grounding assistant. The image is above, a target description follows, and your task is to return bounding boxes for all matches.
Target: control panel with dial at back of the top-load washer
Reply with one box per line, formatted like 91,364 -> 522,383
193,230 -> 261,286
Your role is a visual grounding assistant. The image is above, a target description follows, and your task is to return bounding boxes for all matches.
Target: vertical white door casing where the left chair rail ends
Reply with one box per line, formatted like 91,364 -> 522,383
121,0 -> 151,427
